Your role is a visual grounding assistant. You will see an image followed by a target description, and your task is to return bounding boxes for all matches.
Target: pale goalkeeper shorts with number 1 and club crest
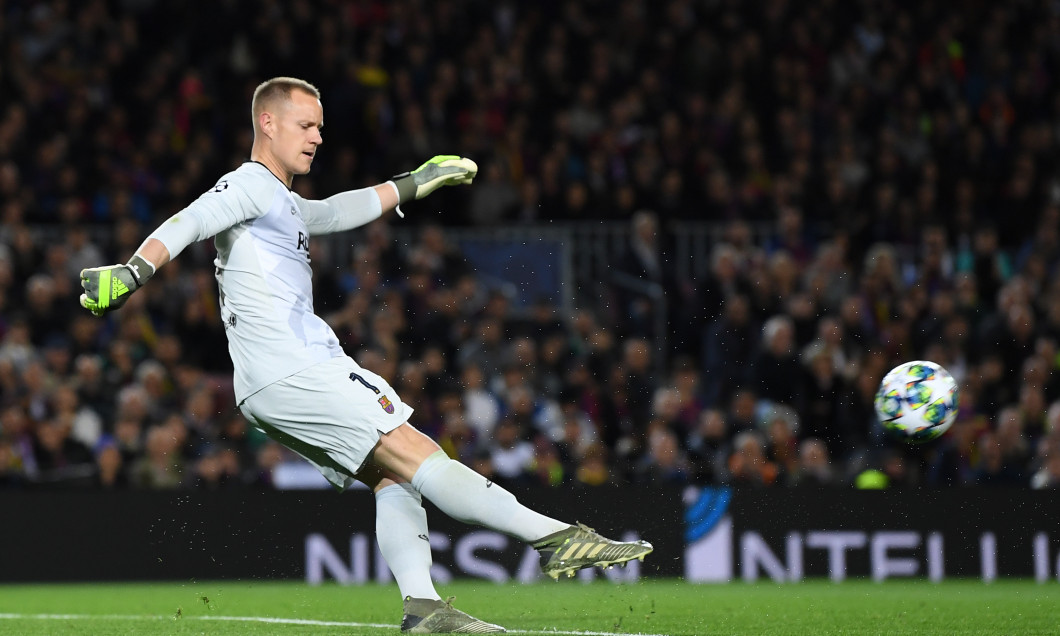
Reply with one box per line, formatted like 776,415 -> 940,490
240,356 -> 412,489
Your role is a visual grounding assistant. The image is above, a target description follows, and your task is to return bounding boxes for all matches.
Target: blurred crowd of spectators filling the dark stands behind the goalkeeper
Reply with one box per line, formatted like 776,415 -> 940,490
0,0 -> 1060,489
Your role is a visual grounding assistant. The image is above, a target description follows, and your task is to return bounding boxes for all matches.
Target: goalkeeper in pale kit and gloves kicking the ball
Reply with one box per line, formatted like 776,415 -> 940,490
81,77 -> 652,634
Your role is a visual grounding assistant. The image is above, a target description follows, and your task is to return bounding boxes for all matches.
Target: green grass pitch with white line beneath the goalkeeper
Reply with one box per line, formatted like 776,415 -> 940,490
0,580 -> 1060,636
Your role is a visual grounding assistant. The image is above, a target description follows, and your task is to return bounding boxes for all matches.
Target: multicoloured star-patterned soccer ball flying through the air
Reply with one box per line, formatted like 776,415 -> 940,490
876,360 -> 957,444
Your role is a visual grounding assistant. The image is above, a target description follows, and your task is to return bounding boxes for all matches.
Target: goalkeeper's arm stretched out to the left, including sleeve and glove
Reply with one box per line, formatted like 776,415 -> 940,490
81,180 -> 257,316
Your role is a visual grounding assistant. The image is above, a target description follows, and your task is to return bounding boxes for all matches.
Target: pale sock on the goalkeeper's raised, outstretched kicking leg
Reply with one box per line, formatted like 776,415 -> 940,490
412,451 -> 570,543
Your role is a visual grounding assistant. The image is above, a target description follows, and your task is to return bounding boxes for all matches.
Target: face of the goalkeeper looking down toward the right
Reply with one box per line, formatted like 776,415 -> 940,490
266,90 -> 324,175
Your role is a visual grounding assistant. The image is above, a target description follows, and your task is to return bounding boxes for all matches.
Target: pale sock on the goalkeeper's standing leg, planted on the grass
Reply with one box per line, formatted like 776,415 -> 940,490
375,483 -> 442,600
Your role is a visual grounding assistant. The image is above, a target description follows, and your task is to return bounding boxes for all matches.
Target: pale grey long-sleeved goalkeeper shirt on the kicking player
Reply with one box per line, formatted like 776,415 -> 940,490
151,161 -> 383,404
